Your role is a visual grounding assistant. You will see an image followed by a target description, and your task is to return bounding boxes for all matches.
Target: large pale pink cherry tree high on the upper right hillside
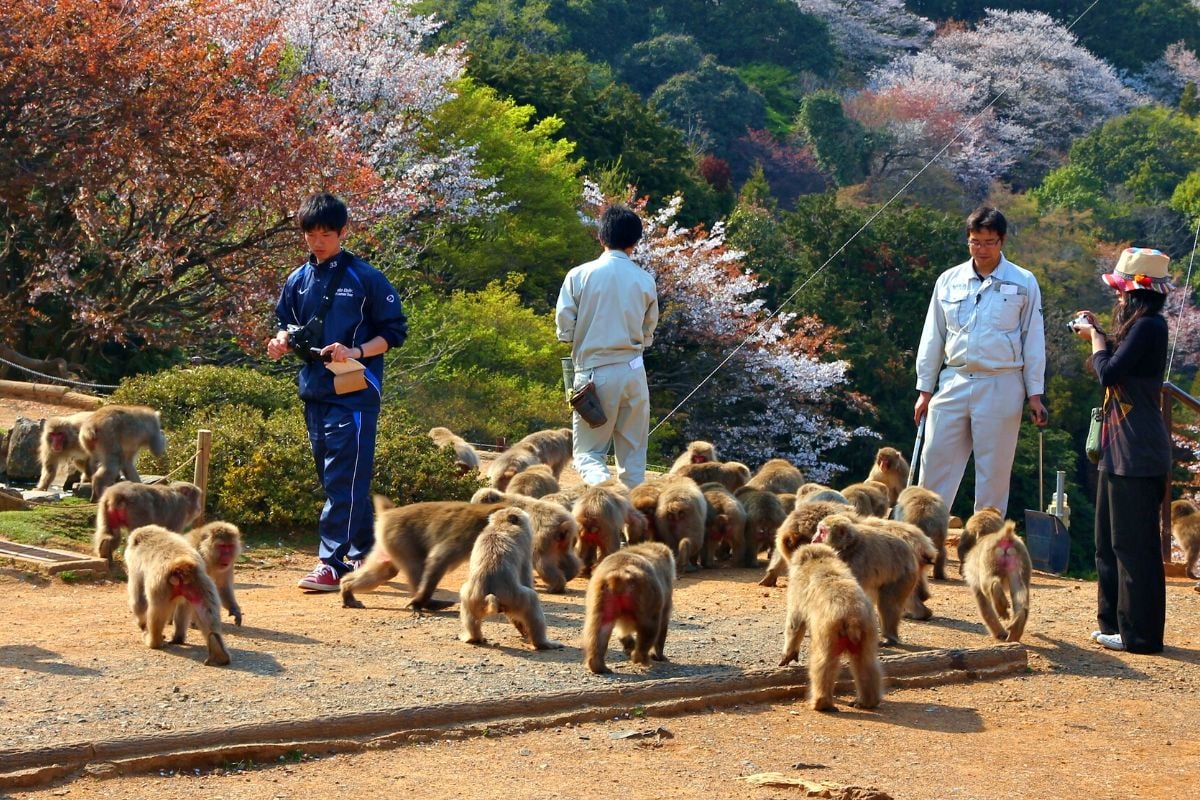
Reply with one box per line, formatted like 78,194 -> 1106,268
850,10 -> 1139,190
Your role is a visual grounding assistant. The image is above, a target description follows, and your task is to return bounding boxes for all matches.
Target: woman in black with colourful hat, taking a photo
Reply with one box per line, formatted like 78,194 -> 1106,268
1075,247 -> 1171,652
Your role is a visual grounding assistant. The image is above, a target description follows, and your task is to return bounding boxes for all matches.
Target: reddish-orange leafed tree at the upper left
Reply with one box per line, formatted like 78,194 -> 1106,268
0,0 -> 373,357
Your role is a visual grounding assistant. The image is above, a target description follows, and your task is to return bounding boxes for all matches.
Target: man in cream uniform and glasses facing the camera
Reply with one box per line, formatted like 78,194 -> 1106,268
913,206 -> 1048,516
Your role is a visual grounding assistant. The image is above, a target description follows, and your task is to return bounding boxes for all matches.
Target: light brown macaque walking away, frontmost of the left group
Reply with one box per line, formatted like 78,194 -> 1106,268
125,525 -> 229,667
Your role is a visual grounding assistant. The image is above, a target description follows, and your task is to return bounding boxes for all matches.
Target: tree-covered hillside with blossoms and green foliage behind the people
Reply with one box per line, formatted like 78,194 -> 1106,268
0,0 -> 1200,569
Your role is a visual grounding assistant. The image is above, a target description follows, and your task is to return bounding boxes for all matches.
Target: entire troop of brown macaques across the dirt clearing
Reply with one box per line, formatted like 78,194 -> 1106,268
40,405 -> 1200,710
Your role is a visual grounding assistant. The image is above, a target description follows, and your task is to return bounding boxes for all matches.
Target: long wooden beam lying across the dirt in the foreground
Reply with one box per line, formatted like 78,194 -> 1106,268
0,644 -> 1028,789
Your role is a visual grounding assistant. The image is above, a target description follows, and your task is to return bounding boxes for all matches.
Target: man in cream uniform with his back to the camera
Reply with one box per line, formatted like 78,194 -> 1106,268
554,205 -> 659,487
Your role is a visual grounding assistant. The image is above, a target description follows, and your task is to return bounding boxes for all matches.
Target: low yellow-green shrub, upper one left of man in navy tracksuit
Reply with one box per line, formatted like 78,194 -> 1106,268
110,366 -> 300,428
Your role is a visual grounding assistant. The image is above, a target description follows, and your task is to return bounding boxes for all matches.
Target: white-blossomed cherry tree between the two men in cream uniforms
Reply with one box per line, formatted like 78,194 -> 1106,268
584,184 -> 874,481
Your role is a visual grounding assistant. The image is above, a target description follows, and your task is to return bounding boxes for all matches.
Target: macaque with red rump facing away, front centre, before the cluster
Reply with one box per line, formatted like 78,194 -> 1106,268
583,542 -> 676,674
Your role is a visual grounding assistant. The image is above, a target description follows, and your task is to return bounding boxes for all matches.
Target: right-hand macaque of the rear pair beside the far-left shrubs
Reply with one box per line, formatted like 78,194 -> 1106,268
79,405 -> 167,500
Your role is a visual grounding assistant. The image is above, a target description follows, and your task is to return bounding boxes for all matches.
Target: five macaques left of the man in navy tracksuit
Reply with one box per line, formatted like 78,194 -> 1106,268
37,405 -> 241,666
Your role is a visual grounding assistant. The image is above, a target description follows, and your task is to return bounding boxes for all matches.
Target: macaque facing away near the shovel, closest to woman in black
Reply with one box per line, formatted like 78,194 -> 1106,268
962,521 -> 1033,642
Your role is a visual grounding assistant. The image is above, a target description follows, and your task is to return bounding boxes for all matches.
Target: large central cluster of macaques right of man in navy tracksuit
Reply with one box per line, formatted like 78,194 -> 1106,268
350,428 -> 1032,710
